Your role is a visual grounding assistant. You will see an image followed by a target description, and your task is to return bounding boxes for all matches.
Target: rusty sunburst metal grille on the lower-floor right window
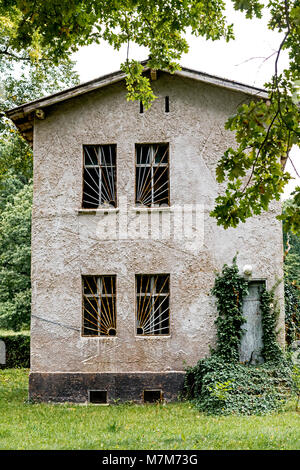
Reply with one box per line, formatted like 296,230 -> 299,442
136,274 -> 170,336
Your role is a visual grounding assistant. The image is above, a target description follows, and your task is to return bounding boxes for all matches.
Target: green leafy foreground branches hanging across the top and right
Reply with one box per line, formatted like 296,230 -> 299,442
0,0 -> 300,232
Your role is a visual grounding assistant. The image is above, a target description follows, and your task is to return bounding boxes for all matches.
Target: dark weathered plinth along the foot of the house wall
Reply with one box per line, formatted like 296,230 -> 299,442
29,372 -> 185,403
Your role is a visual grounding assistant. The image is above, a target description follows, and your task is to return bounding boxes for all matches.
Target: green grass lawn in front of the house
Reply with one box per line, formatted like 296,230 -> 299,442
0,369 -> 300,450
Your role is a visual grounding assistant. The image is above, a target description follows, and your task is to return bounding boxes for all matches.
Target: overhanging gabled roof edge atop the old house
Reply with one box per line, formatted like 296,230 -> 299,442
5,61 -> 268,142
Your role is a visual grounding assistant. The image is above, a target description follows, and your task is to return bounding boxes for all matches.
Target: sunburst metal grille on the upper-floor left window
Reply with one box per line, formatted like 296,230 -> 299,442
82,145 -> 117,209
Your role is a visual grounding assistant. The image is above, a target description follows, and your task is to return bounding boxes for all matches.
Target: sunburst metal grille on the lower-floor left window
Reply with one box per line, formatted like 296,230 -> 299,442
82,276 -> 117,336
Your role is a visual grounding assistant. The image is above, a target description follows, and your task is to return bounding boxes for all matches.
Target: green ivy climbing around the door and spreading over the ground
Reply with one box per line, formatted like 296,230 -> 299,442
184,258 -> 294,415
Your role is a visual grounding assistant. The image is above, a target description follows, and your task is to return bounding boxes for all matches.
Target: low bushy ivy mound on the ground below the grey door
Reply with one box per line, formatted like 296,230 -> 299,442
185,354 -> 293,415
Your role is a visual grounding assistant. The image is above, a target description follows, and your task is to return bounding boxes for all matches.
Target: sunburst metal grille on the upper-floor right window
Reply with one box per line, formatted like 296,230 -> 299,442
135,144 -> 170,207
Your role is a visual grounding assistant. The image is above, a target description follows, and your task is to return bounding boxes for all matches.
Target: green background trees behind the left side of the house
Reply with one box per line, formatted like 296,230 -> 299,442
0,8 -> 79,330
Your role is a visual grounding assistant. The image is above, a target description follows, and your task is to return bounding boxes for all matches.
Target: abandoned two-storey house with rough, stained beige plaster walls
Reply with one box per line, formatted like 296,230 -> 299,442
7,64 -> 284,403
